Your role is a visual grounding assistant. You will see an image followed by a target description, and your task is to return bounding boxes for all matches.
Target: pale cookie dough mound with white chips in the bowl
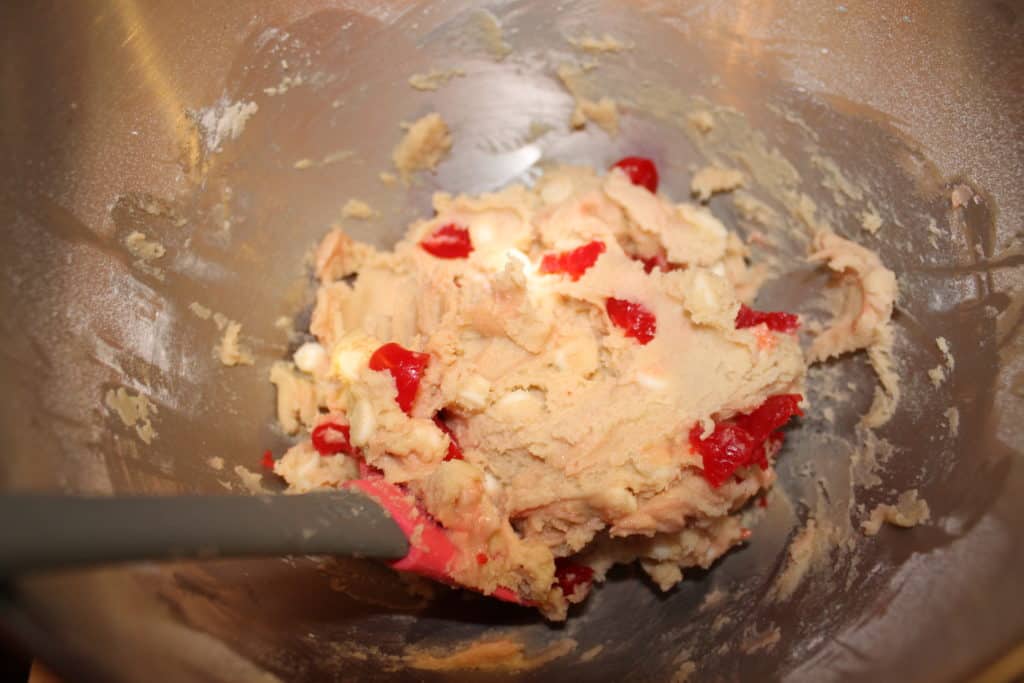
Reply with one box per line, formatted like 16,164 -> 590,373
272,167 -> 815,620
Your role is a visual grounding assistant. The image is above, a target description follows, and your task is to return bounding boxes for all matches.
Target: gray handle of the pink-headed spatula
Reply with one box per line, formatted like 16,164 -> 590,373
0,490 -> 409,578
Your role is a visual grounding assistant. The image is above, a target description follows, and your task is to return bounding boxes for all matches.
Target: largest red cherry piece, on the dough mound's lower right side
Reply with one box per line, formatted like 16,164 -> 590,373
690,393 -> 804,488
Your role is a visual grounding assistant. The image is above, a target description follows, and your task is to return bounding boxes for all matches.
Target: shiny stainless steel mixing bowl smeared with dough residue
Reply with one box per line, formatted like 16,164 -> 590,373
0,0 -> 1024,681
